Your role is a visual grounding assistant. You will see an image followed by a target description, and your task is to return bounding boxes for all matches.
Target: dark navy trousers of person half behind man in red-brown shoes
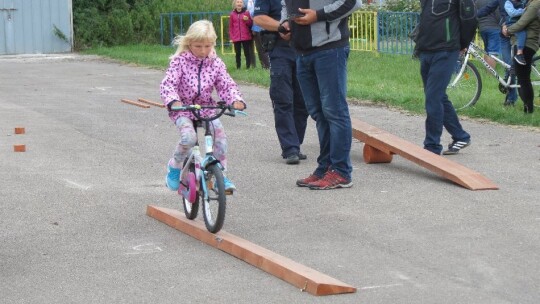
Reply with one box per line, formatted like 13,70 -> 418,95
268,46 -> 308,158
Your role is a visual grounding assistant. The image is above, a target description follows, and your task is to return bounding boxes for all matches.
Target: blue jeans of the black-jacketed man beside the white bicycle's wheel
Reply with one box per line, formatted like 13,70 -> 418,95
420,51 -> 471,154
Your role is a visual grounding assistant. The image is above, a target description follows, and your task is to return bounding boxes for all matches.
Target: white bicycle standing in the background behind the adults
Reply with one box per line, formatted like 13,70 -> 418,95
446,42 -> 540,110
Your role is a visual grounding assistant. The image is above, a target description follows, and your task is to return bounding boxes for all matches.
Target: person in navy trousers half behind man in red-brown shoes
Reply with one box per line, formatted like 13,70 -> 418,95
253,0 -> 308,165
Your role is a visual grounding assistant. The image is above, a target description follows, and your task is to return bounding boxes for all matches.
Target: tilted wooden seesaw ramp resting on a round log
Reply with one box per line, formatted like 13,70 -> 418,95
351,118 -> 499,190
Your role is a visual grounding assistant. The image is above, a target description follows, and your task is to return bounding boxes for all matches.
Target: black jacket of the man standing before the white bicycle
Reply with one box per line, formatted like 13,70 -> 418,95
416,0 -> 478,52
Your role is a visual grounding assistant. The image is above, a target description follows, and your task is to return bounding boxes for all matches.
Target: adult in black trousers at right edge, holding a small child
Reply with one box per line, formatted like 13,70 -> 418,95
502,0 -> 540,114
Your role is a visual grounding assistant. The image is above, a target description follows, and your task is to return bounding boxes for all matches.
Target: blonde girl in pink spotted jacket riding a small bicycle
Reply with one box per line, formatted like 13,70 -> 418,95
160,20 -> 246,191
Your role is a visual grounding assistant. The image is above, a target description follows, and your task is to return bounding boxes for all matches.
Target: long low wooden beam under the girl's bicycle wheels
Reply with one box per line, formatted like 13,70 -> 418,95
146,205 -> 356,296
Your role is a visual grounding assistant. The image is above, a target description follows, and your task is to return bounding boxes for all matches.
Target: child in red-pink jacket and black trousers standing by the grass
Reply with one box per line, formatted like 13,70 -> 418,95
229,0 -> 253,69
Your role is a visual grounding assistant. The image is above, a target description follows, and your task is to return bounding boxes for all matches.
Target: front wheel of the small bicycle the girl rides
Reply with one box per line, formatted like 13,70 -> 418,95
204,165 -> 227,233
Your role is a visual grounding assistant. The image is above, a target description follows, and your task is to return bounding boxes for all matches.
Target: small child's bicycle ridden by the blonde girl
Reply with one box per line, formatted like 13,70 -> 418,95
171,101 -> 245,233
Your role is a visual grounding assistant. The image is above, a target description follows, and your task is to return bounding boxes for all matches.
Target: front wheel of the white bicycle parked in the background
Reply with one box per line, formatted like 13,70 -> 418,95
446,61 -> 482,110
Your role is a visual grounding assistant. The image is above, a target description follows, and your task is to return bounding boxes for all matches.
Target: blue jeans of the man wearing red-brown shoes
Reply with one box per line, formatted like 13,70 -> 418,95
296,46 -> 352,180
